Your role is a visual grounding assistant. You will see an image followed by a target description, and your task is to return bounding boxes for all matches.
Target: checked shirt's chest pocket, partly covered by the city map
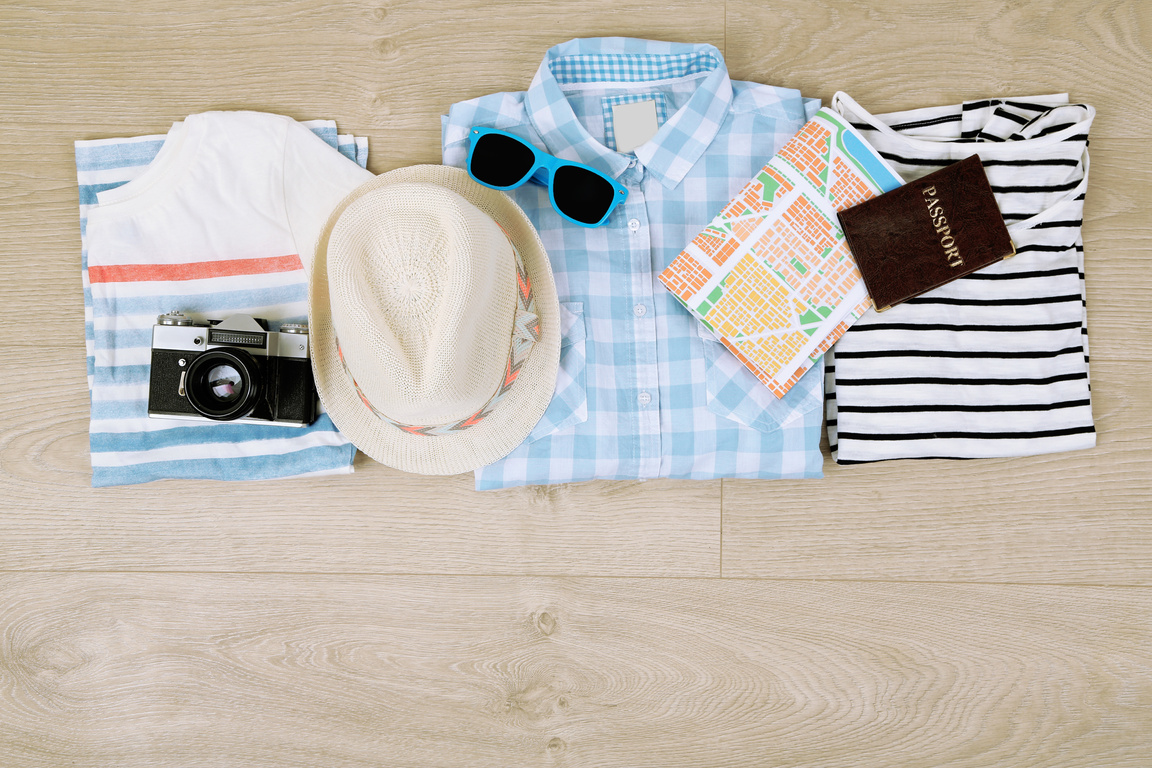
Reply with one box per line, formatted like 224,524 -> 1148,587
697,324 -> 824,432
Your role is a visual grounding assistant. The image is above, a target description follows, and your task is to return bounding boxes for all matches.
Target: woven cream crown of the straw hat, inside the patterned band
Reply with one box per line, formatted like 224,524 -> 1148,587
328,182 -> 516,425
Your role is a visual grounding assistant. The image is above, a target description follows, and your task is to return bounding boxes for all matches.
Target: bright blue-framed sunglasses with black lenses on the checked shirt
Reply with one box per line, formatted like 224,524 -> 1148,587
468,127 -> 628,227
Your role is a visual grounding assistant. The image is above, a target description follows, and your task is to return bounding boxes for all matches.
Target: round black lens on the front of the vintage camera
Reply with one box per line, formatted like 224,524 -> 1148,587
184,349 -> 260,421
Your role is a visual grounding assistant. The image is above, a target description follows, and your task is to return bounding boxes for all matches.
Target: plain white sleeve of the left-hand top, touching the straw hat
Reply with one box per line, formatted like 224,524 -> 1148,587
283,120 -> 374,276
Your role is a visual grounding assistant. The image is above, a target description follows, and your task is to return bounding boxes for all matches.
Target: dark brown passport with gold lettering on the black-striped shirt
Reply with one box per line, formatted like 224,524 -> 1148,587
838,154 -> 1016,312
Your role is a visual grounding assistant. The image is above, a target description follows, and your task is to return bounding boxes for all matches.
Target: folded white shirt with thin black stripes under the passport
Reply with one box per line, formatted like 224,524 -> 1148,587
826,93 -> 1096,464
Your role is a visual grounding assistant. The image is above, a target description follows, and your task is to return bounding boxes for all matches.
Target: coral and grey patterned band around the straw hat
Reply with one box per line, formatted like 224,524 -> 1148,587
335,227 -> 540,436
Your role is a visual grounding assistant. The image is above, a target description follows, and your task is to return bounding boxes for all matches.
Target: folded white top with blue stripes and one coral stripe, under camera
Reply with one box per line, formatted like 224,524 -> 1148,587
76,112 -> 372,486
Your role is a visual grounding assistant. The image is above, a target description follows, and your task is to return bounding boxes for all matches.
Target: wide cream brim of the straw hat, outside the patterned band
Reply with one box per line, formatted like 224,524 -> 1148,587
308,165 -> 560,474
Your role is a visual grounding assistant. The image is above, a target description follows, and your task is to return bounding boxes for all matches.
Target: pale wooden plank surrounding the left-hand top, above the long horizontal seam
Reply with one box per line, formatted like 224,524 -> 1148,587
0,1 -> 723,576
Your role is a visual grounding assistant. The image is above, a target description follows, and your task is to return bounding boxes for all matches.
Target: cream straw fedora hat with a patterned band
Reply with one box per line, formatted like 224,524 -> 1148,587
309,166 -> 560,474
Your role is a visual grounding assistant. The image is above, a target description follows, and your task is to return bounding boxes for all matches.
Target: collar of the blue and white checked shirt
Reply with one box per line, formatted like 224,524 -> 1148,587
524,37 -> 732,189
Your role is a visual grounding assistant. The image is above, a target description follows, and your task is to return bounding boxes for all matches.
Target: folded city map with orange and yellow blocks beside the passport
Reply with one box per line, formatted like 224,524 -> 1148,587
660,108 -> 903,397
